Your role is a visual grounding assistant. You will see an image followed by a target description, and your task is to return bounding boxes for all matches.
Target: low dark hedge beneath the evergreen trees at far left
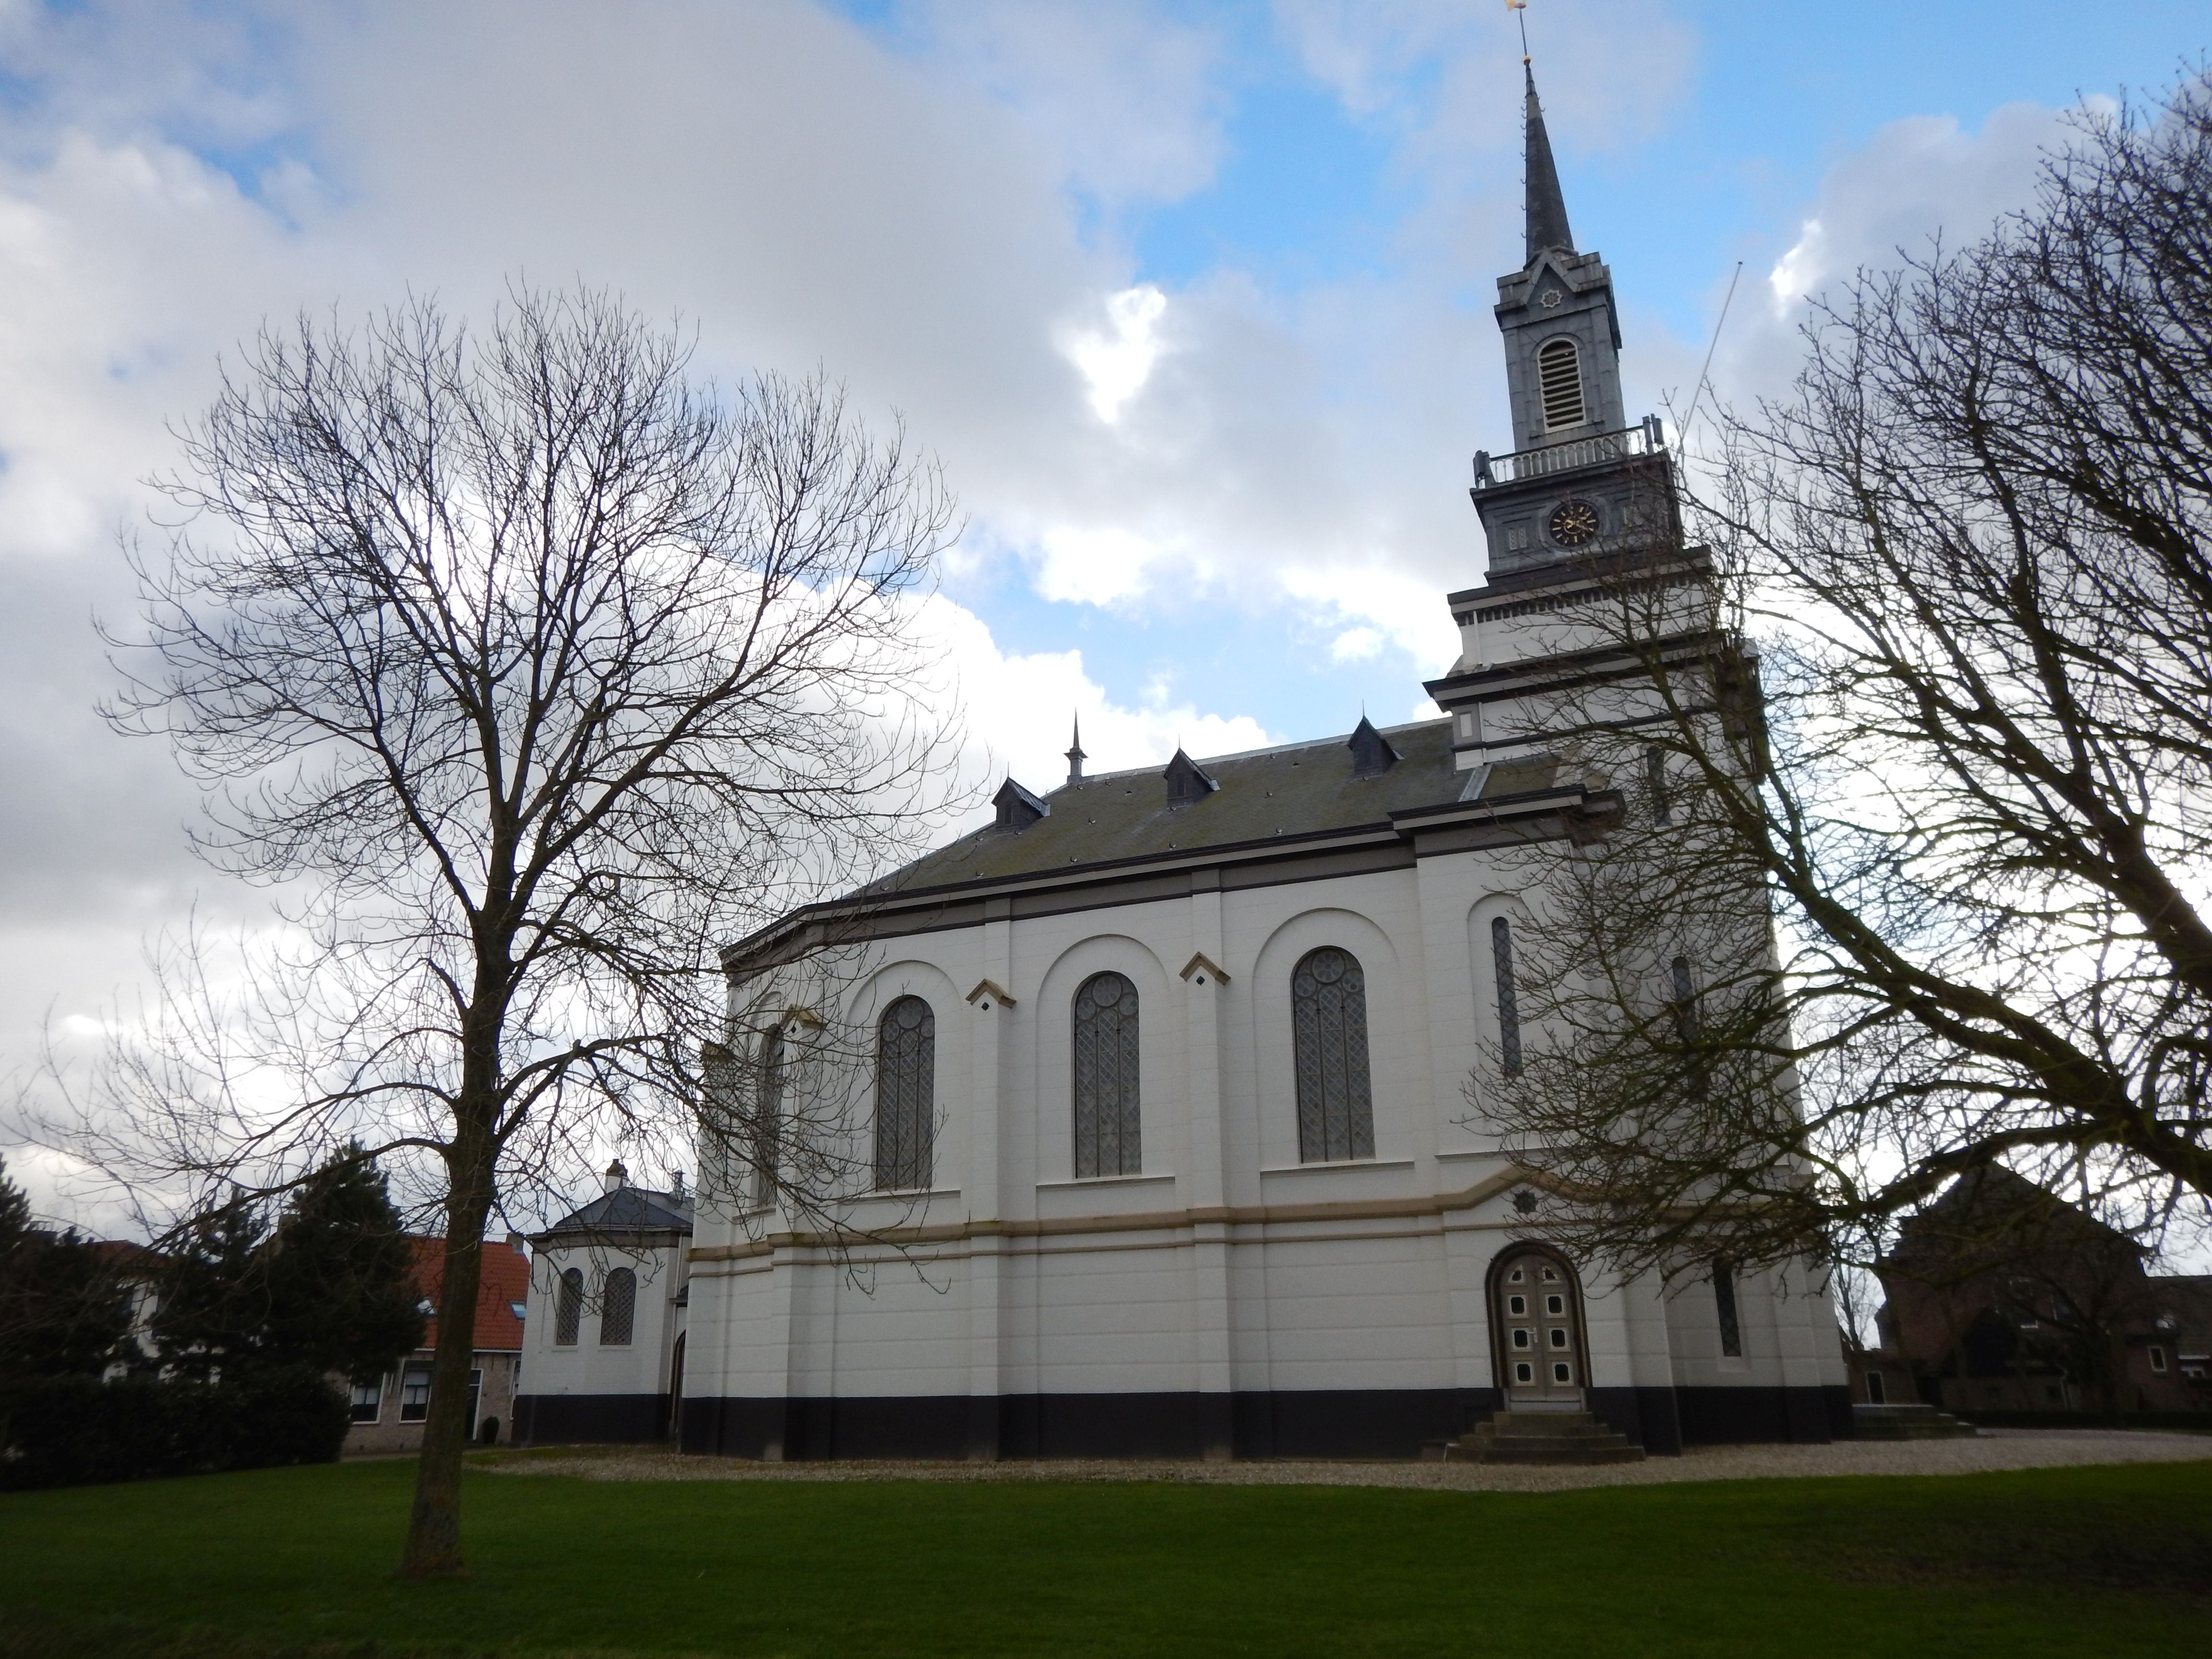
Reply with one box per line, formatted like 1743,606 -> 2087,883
0,1369 -> 349,1489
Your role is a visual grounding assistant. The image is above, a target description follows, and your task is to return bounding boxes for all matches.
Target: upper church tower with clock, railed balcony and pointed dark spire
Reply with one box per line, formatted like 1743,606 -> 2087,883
1427,60 -> 1681,770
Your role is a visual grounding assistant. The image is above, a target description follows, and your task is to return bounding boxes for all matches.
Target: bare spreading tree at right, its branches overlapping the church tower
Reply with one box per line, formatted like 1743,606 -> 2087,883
1469,69 -> 2212,1272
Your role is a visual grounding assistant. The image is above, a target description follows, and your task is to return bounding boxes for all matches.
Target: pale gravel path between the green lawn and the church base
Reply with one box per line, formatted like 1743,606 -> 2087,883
484,1429 -> 2212,1491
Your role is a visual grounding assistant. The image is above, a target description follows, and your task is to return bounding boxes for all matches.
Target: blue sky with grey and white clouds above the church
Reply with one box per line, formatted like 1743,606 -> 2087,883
0,0 -> 2212,1221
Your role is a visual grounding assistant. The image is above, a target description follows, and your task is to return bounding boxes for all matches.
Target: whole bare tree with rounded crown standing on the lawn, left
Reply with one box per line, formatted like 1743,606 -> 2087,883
58,290 -> 951,1577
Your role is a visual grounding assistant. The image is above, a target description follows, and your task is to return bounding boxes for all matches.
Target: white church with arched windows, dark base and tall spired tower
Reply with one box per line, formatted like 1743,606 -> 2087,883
517,77 -> 1851,1458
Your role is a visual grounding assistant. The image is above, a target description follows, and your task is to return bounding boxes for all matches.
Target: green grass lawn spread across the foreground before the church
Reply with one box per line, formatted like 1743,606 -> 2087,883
0,1462 -> 2212,1659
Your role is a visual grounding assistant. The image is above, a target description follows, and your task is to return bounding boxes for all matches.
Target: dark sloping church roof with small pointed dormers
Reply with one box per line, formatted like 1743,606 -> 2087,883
876,721 -> 1551,891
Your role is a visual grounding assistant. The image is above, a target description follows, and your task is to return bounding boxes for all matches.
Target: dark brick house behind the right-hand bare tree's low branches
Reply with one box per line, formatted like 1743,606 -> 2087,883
1849,1168 -> 2212,1414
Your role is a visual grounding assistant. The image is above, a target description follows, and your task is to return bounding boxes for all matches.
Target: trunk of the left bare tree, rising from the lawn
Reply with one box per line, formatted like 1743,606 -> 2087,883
400,1130 -> 491,1579
